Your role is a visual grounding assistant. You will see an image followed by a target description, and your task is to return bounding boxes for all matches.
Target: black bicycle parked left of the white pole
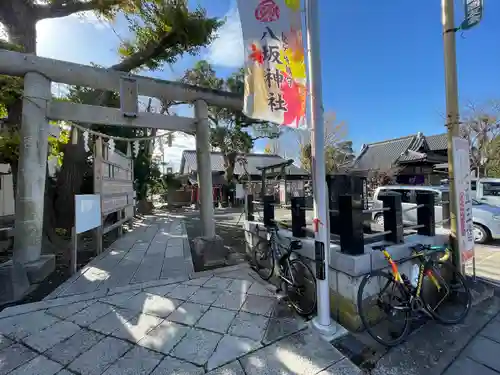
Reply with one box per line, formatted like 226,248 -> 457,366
252,226 -> 317,316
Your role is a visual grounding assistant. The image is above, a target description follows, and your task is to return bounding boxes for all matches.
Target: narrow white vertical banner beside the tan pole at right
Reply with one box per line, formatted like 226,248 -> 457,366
453,137 -> 474,264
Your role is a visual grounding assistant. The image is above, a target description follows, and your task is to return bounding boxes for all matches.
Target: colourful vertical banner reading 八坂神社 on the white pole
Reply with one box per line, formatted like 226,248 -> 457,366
238,0 -> 306,128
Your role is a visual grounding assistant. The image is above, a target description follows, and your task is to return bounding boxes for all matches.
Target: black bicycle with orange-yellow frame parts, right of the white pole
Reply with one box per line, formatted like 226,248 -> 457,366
358,244 -> 472,346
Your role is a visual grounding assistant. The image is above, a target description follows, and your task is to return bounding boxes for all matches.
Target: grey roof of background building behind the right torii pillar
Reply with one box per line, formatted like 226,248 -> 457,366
180,150 -> 308,176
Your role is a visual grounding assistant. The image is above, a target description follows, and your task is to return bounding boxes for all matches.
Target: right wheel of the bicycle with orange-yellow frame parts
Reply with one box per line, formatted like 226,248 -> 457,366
421,262 -> 472,325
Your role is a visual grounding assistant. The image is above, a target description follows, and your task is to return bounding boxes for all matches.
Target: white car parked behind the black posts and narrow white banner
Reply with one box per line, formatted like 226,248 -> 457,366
372,185 -> 500,243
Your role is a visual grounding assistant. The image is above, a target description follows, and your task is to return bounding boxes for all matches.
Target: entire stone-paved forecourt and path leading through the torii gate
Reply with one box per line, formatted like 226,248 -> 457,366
0,215 -> 360,375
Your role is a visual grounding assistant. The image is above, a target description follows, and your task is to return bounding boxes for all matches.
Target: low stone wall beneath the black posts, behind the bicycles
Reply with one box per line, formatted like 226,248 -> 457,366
244,221 -> 448,331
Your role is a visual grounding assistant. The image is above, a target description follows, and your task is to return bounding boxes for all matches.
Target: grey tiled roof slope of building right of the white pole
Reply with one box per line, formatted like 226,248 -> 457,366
354,135 -> 416,170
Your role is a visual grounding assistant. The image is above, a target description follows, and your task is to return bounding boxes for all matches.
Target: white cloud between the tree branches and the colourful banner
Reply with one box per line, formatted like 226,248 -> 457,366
206,7 -> 245,68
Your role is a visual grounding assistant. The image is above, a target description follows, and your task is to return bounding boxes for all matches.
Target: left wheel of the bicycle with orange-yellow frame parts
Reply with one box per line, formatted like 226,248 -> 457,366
358,271 -> 410,346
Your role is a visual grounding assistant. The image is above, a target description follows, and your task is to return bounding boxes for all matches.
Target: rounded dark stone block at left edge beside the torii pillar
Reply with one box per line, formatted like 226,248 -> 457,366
0,260 -> 30,305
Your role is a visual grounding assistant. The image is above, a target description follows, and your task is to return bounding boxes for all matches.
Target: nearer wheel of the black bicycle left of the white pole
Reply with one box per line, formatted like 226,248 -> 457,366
283,258 -> 317,316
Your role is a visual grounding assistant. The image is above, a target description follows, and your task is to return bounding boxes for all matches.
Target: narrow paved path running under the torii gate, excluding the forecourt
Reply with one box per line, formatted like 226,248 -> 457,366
47,214 -> 193,299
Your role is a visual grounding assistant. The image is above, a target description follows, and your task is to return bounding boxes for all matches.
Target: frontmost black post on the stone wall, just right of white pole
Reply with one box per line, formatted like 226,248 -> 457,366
338,195 -> 365,255
